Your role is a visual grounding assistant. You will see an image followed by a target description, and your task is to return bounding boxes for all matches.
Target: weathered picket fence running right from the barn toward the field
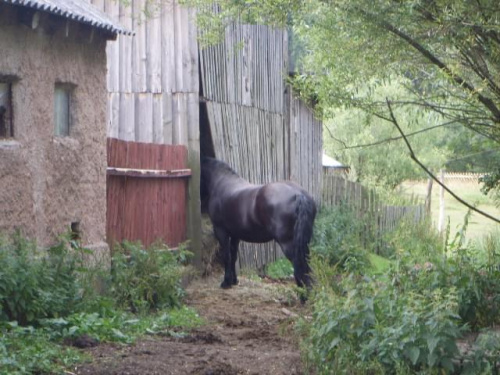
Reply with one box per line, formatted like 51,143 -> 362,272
322,175 -> 426,241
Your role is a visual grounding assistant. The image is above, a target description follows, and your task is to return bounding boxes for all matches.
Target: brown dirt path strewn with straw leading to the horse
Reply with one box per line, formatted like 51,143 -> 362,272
76,277 -> 303,375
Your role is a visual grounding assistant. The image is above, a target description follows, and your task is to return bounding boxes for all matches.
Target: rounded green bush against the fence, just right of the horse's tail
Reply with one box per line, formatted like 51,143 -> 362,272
310,205 -> 370,272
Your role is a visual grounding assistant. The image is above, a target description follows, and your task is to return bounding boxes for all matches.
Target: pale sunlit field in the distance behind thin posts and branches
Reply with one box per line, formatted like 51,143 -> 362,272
402,180 -> 500,244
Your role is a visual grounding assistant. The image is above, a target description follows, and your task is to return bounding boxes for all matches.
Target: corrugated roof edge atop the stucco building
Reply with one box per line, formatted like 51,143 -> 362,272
0,0 -> 133,35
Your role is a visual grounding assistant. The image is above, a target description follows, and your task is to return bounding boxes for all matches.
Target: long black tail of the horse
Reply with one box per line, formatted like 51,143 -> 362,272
293,194 -> 316,286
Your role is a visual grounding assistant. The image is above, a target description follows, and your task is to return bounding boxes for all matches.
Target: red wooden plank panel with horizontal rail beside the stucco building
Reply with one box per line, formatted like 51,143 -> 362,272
106,138 -> 191,247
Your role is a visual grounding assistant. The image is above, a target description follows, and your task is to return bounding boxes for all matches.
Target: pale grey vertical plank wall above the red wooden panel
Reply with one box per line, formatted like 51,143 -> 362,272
91,0 -> 199,145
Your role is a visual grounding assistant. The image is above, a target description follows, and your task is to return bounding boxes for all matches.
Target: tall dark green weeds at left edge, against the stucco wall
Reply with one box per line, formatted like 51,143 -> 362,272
0,234 -> 86,325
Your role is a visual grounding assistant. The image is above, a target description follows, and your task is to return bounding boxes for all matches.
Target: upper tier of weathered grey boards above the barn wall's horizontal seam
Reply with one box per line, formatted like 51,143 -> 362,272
200,24 -> 288,114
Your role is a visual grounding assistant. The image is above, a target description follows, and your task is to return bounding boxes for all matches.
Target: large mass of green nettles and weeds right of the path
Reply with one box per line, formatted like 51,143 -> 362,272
300,218 -> 500,374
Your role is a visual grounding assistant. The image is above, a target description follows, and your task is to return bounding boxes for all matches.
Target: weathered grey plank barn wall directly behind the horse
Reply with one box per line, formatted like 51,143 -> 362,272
200,24 -> 322,268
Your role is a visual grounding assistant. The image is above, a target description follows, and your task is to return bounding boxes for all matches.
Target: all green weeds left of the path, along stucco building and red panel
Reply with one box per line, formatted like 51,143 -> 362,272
0,234 -> 202,374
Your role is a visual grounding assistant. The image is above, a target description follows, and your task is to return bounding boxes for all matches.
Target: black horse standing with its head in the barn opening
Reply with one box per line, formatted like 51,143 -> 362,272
200,157 -> 316,288
